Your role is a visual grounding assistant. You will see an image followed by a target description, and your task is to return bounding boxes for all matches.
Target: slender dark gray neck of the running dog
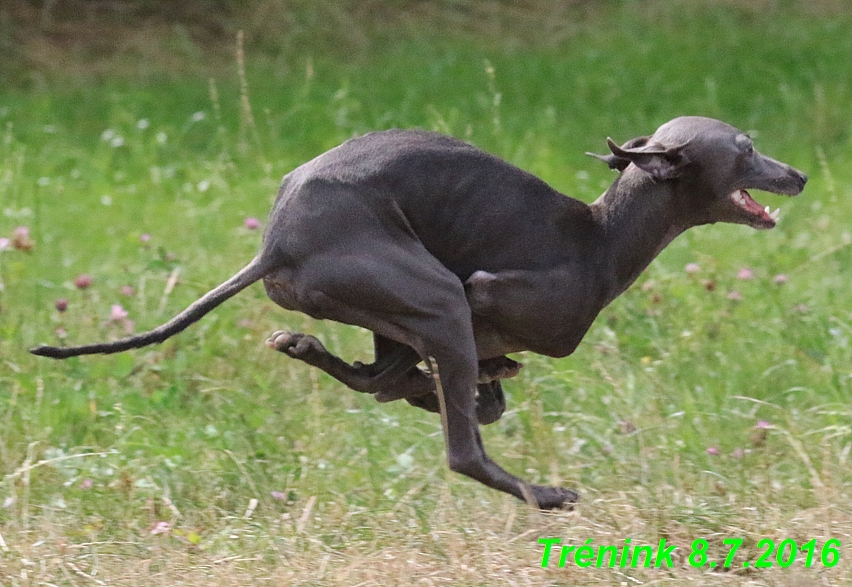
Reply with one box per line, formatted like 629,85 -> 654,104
591,170 -> 690,304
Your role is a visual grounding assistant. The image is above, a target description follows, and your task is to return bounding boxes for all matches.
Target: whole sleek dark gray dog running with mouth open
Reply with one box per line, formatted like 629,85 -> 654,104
32,117 -> 807,508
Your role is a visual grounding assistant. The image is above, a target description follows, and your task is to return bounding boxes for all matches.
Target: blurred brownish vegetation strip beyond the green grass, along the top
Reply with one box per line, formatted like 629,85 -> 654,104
0,0 -> 849,84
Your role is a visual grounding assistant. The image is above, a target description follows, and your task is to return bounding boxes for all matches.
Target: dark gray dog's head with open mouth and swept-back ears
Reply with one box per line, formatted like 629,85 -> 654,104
589,116 -> 808,228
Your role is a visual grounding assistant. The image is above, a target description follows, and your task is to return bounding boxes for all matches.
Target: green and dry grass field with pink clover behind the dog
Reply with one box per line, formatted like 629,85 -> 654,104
0,1 -> 852,587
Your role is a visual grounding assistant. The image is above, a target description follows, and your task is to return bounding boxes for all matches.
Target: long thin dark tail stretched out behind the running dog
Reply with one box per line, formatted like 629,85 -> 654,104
30,256 -> 274,359
